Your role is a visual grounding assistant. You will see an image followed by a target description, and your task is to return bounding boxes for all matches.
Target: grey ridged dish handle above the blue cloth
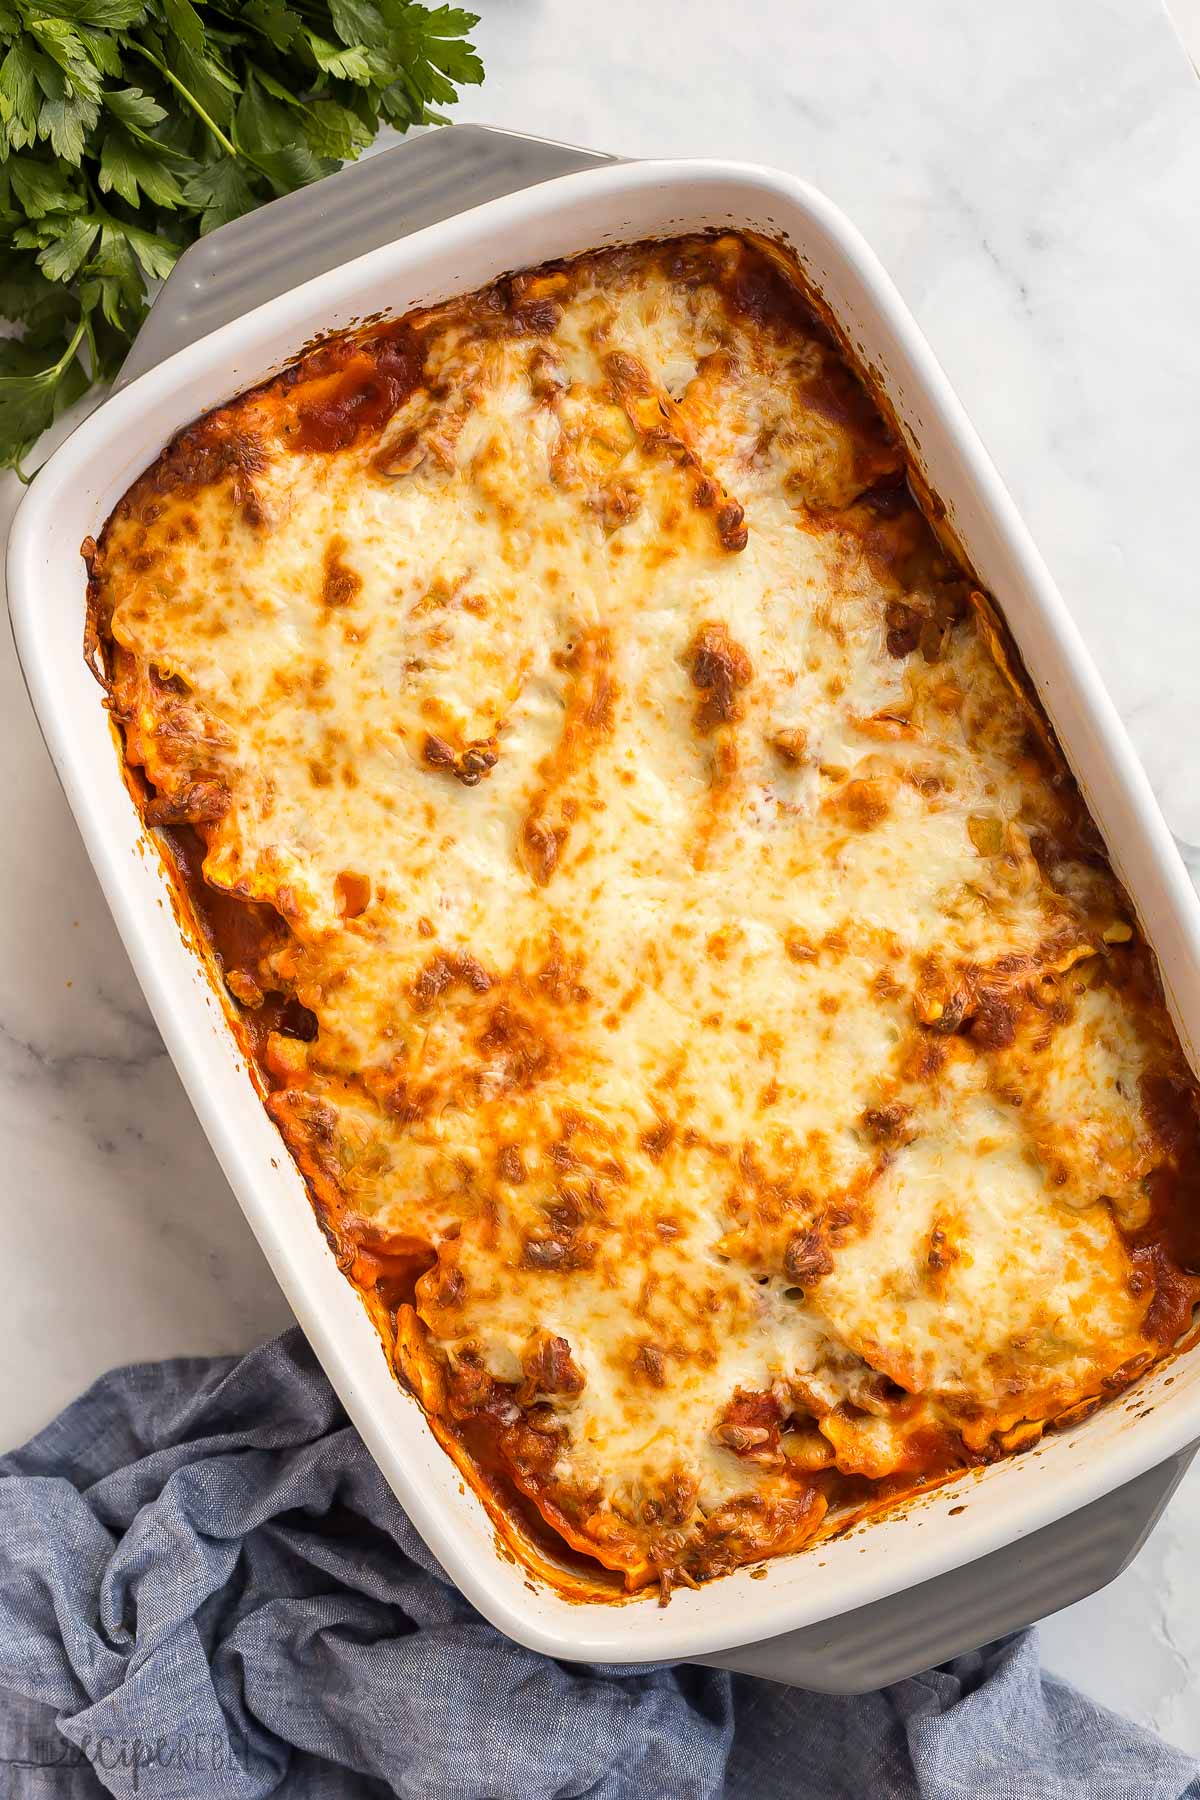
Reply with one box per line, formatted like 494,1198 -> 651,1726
694,1445 -> 1196,1694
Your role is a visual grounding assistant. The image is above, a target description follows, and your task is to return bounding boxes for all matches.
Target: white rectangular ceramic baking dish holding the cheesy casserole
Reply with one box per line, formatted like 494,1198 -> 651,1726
9,128 -> 1200,1687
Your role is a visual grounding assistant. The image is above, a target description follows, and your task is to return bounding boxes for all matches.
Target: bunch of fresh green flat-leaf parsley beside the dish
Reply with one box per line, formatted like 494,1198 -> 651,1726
0,0 -> 484,470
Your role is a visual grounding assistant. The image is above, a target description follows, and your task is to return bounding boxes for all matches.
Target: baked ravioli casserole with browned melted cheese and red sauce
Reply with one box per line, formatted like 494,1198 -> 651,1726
85,234 -> 1200,1598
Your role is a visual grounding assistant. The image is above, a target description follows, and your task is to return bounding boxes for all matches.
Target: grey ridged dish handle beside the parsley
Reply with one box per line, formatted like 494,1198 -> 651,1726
113,124 -> 621,392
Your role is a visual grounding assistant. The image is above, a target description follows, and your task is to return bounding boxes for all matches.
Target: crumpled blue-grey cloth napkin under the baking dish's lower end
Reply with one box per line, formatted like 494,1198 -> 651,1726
0,1330 -> 1200,1800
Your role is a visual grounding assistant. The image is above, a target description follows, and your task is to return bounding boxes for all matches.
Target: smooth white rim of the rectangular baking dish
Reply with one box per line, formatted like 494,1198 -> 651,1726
9,158 -> 1200,1663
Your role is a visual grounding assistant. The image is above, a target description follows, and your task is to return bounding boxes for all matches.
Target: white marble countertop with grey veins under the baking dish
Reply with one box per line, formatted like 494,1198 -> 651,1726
0,0 -> 1200,1751
